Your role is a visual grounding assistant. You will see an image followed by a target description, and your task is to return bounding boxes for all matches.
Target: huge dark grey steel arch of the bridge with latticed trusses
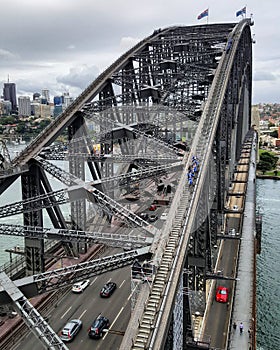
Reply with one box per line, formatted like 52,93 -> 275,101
0,19 -> 252,350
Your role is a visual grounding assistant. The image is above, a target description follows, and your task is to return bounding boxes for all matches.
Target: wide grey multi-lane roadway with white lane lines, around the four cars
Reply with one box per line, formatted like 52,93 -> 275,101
13,267 -> 131,350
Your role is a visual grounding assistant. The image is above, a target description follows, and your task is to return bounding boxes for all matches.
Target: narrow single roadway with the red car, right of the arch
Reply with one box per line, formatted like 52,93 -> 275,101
201,150 -> 249,349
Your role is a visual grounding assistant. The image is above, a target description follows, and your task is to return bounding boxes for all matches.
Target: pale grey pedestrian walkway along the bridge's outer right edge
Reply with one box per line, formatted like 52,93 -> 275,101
228,133 -> 256,350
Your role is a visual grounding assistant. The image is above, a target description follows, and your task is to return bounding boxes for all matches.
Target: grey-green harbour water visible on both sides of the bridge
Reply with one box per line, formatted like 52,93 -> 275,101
0,152 -> 280,350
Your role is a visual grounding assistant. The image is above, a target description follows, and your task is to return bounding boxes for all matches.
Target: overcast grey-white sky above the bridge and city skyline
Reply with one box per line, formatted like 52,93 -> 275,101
0,0 -> 280,103
